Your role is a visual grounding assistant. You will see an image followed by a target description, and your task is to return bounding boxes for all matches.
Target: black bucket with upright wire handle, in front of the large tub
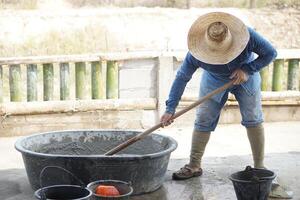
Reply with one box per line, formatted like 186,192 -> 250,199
34,166 -> 92,200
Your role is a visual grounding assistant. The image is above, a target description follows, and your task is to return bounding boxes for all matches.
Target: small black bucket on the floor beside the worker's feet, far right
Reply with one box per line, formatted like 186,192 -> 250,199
230,166 -> 276,200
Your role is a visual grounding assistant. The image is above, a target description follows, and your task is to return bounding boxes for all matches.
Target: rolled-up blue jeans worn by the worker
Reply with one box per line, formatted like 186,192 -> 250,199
194,73 -> 263,132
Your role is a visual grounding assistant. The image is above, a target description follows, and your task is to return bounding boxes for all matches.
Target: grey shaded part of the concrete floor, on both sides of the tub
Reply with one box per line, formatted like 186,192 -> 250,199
0,152 -> 300,200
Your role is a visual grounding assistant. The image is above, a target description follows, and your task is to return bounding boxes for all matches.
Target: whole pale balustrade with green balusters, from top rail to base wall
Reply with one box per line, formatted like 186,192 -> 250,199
0,50 -> 300,137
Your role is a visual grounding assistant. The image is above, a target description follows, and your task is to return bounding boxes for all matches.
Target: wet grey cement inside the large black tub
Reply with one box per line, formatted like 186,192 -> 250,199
35,138 -> 168,156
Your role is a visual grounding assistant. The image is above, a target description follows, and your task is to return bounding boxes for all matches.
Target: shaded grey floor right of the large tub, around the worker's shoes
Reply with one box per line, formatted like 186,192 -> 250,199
132,153 -> 300,200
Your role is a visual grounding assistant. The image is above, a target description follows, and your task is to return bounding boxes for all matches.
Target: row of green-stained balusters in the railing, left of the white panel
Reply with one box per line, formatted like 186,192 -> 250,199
0,61 -> 118,102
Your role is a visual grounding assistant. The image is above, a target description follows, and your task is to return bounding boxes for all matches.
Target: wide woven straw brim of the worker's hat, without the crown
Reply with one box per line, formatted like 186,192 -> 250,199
188,12 -> 250,65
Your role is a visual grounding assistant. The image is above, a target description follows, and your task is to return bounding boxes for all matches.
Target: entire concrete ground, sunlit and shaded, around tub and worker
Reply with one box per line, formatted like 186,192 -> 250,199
0,122 -> 300,200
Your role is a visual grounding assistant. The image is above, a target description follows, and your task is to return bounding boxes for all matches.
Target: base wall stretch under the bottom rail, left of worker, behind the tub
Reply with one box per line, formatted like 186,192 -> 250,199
0,110 -> 156,137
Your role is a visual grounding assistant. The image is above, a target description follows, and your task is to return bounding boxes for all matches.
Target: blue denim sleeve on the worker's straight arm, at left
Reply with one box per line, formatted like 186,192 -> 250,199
166,52 -> 198,114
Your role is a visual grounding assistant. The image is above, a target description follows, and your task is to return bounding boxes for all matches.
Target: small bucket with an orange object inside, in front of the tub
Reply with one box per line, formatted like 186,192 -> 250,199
87,180 -> 133,200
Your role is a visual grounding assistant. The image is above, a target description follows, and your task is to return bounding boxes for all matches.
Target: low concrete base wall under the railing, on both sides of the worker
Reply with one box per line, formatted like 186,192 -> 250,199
0,106 -> 300,137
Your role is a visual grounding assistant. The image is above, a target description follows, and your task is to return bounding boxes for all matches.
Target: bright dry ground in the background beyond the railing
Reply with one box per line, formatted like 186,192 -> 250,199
0,6 -> 300,57
